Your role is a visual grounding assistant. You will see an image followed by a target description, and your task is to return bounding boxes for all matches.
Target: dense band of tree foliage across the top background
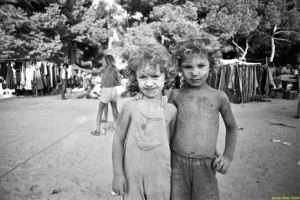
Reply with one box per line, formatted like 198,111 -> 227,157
0,0 -> 300,63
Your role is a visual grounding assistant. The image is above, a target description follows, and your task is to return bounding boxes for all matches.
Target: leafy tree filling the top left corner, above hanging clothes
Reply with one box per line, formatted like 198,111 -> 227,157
0,0 -> 91,59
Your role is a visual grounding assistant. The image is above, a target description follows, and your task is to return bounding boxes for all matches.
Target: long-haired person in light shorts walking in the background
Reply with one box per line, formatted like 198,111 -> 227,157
75,55 -> 119,136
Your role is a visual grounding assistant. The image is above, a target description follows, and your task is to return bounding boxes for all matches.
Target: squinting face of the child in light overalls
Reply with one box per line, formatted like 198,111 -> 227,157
136,64 -> 165,99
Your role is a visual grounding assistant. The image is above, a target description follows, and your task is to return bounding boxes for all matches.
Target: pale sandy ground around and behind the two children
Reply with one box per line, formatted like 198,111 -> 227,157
0,96 -> 300,200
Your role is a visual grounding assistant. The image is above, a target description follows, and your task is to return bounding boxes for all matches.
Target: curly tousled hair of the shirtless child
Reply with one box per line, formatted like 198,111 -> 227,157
169,33 -> 221,69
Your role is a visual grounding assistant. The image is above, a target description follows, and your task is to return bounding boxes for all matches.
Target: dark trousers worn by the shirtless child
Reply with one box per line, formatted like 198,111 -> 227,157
171,149 -> 220,200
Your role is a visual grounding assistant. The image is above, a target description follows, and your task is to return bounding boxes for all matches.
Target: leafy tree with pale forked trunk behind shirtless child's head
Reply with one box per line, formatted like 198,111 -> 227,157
195,0 -> 260,59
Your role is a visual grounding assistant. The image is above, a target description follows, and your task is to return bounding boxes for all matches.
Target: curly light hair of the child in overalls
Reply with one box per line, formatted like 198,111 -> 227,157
125,44 -> 177,91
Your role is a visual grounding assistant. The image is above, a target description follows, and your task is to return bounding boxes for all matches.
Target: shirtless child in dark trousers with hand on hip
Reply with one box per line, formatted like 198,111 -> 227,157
169,38 -> 237,200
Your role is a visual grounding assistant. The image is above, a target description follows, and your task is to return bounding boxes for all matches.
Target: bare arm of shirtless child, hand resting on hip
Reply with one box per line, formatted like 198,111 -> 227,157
213,92 -> 237,174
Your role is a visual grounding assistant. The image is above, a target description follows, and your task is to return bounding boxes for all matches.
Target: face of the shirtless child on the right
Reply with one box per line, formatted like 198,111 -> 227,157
180,52 -> 209,87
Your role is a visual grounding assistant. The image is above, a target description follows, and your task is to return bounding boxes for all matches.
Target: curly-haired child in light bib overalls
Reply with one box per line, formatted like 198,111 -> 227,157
112,44 -> 176,200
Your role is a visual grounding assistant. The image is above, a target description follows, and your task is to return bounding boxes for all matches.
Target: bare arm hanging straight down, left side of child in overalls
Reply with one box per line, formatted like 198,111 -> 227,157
112,102 -> 131,195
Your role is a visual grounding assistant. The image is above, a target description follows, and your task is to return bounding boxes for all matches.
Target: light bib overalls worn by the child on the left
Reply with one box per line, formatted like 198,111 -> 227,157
124,100 -> 171,200
